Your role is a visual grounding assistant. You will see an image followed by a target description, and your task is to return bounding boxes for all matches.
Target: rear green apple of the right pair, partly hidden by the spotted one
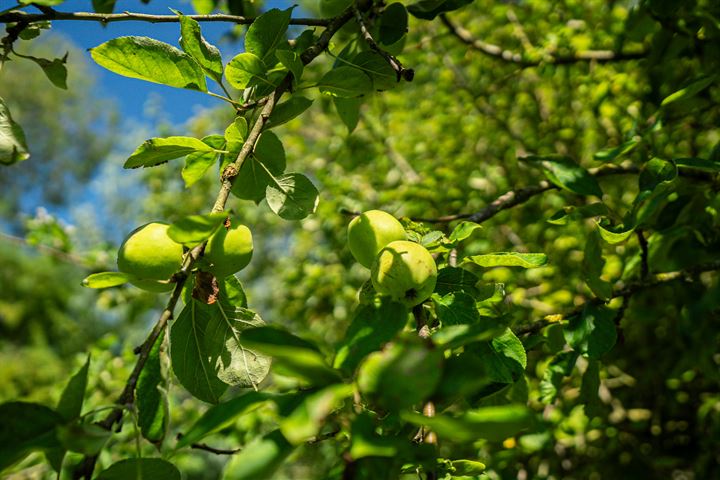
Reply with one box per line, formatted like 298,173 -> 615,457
348,210 -> 407,268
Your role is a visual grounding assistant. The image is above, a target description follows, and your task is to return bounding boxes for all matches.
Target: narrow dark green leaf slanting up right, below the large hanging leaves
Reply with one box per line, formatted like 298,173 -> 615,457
175,391 -> 272,450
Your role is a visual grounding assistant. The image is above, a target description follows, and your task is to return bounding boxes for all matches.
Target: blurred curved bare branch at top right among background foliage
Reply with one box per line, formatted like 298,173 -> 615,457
440,14 -> 648,68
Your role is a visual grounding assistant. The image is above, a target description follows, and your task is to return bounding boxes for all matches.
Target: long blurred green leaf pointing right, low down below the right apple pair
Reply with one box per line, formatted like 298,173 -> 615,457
400,405 -> 534,442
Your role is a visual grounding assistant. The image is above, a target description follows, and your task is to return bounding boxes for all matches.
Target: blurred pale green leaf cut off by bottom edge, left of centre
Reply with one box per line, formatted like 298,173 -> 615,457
222,429 -> 294,480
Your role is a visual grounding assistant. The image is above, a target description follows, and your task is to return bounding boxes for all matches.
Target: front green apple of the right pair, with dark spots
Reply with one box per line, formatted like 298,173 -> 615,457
370,240 -> 437,307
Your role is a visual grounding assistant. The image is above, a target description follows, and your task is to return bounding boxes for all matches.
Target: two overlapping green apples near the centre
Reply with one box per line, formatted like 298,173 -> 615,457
348,210 -> 437,307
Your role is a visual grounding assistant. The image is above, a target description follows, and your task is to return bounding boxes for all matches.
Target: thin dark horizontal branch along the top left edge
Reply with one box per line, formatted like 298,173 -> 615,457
0,8 -> 332,27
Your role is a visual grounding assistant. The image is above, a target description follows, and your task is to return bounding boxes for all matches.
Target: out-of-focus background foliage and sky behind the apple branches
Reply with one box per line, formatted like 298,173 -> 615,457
0,0 -> 720,479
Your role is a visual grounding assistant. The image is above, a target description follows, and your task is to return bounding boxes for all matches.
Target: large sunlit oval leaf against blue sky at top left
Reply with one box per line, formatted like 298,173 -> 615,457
90,37 -> 207,92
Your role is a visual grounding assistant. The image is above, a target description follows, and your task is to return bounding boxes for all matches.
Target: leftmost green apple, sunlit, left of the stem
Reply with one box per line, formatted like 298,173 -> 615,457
117,222 -> 183,292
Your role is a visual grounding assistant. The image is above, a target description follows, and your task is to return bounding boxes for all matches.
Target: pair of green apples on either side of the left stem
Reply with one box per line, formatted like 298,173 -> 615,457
117,222 -> 253,292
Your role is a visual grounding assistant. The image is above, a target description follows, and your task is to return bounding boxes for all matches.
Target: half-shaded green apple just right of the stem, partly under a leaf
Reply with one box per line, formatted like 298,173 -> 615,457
203,225 -> 253,278
